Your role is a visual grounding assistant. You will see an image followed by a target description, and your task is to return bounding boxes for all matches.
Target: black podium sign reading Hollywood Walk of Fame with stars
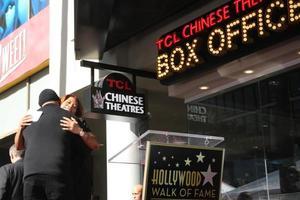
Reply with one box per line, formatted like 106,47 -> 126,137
143,142 -> 224,200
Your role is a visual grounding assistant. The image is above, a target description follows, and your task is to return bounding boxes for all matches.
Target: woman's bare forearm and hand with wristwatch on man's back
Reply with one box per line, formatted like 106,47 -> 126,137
60,117 -> 101,150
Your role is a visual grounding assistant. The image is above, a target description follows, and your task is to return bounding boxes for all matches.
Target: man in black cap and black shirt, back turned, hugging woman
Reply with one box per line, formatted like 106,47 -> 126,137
22,89 -> 77,200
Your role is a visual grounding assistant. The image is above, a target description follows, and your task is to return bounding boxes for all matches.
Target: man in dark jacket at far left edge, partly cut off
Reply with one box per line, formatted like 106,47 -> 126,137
0,145 -> 24,200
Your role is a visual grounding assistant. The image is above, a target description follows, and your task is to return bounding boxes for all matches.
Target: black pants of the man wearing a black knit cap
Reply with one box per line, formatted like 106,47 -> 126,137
23,175 -> 71,200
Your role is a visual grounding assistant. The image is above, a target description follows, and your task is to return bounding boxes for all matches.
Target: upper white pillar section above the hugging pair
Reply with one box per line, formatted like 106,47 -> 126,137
50,1 -> 97,95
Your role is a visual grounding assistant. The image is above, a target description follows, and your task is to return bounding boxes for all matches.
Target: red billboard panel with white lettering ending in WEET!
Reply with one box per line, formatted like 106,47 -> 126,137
0,7 -> 49,92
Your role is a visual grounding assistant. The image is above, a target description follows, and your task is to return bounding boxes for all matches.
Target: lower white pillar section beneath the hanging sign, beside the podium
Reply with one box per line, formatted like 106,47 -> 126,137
106,120 -> 141,200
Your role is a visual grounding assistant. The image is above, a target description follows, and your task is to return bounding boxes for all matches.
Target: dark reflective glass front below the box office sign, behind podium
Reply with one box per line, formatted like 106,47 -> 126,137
187,69 -> 300,199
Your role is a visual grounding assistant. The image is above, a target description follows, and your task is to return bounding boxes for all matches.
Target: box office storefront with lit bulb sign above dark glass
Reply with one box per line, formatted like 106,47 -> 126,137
152,1 -> 300,199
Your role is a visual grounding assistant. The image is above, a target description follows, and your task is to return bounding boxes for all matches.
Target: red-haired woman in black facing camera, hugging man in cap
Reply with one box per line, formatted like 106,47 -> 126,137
60,94 -> 100,200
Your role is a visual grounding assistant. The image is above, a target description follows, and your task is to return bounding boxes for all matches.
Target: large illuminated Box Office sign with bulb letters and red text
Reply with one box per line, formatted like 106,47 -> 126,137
156,0 -> 300,84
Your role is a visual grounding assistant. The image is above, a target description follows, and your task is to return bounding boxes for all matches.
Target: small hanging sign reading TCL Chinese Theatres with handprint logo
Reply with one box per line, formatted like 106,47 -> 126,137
91,73 -> 146,117
